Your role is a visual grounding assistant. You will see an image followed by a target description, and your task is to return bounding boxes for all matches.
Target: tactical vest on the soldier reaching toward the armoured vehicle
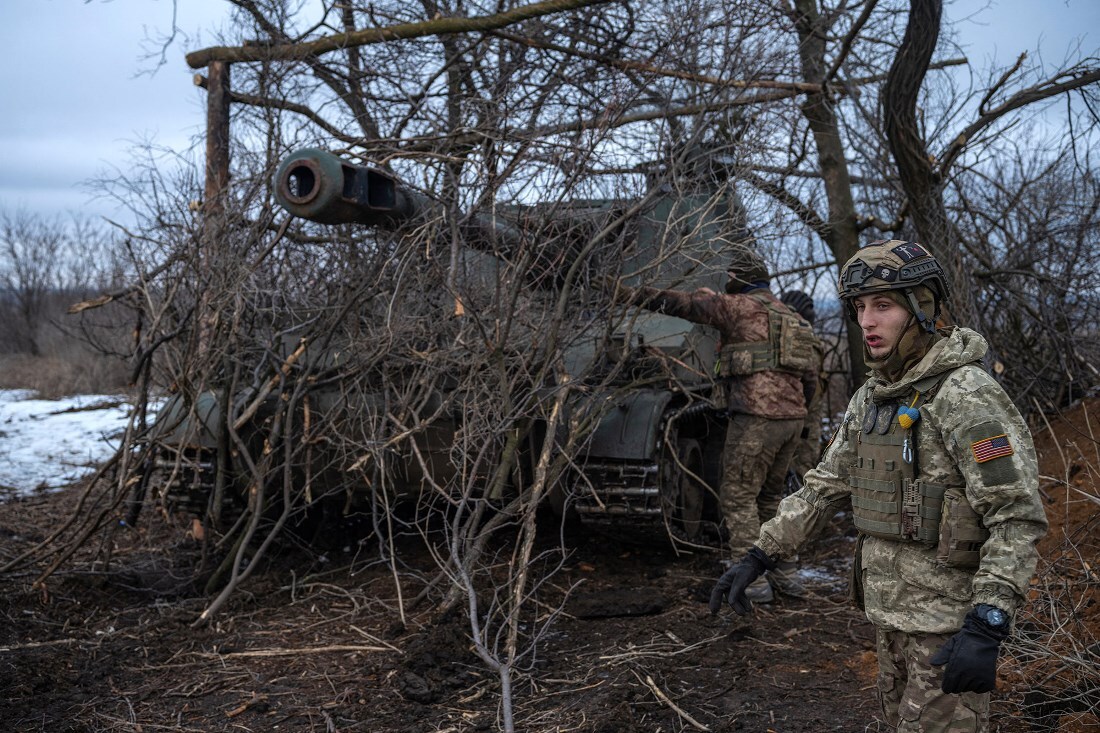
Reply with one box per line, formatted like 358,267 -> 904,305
714,292 -> 817,376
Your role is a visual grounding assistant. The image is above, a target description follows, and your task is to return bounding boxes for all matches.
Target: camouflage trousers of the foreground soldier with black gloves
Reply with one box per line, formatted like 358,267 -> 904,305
876,628 -> 989,733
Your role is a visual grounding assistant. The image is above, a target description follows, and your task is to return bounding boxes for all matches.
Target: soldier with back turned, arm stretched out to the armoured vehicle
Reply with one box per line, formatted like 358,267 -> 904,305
619,247 -> 816,603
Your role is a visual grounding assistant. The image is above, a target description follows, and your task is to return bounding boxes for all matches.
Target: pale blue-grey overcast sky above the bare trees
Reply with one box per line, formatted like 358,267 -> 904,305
0,0 -> 1100,221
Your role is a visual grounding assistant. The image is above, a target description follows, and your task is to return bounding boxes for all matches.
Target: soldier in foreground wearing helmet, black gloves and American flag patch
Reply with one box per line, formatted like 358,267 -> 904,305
711,240 -> 1046,733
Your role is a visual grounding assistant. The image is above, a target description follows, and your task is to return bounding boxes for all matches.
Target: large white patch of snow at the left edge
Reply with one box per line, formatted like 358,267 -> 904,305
0,390 -> 146,495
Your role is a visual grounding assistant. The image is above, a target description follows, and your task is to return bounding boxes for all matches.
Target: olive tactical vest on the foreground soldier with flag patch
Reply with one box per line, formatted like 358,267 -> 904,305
848,372 -> 989,568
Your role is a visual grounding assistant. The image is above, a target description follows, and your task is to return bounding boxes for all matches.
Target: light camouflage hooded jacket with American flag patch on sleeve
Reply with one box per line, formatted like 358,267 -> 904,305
757,328 -> 1047,634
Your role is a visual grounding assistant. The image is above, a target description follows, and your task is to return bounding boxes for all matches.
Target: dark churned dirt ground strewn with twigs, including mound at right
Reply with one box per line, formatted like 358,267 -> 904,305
0,401 -> 1100,733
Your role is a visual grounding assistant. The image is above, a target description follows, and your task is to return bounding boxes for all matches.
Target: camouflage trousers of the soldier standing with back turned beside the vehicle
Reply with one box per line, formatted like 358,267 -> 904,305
719,414 -> 802,550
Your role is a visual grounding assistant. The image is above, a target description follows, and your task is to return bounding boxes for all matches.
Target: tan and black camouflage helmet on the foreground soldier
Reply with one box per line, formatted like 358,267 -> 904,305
837,239 -> 947,333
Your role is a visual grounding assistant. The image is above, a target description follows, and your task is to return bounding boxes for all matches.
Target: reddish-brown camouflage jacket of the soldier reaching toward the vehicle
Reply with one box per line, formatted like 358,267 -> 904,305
624,287 -> 817,419
